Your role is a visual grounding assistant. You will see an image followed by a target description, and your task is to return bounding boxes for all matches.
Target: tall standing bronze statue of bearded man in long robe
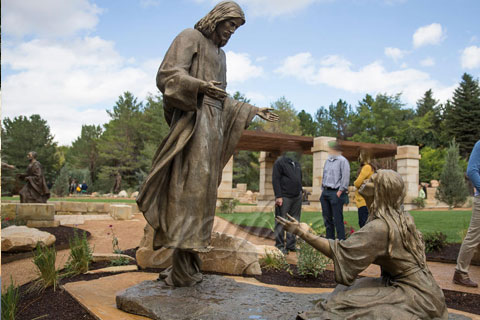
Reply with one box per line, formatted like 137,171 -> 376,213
137,1 -> 278,286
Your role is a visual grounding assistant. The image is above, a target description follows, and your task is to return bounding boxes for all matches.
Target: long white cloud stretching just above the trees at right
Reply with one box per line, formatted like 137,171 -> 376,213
275,52 -> 455,104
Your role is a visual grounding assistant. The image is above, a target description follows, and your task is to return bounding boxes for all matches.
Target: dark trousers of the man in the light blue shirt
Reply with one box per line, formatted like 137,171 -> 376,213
320,189 -> 345,240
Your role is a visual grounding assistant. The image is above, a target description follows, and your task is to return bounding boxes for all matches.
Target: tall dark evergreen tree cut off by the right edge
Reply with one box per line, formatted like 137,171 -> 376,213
446,73 -> 480,158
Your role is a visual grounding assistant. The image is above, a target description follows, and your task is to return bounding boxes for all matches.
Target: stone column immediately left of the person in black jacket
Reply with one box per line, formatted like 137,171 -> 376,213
257,151 -> 280,206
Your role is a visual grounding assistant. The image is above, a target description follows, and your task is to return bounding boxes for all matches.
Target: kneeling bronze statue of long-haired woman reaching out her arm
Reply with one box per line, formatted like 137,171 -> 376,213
277,170 -> 448,320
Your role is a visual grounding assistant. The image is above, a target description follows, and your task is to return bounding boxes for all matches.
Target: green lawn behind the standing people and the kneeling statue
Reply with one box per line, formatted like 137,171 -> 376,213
217,210 -> 472,243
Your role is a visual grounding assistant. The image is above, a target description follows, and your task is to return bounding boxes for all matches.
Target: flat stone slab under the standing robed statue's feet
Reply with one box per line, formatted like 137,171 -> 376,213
116,275 -> 322,320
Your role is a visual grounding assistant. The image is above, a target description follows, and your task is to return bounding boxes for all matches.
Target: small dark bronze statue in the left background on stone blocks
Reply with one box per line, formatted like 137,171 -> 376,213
18,151 -> 50,203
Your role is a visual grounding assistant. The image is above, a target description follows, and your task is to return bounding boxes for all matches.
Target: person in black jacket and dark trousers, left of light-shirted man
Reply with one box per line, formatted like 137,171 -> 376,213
272,154 -> 303,254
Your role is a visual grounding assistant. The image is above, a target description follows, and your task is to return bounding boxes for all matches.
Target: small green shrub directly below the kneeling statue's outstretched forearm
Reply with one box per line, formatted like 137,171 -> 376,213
297,239 -> 329,278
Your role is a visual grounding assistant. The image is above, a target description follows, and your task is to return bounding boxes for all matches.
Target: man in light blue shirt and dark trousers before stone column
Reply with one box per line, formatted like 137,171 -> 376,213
320,143 -> 350,240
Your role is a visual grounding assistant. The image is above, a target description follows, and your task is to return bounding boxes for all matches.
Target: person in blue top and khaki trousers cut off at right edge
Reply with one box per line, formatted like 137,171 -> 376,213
453,140 -> 480,288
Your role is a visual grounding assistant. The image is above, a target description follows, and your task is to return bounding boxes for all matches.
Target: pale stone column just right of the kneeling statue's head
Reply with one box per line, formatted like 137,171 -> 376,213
395,146 -> 421,210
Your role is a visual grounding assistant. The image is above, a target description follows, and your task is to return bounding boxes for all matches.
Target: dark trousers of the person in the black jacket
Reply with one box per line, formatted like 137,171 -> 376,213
274,193 -> 302,250
